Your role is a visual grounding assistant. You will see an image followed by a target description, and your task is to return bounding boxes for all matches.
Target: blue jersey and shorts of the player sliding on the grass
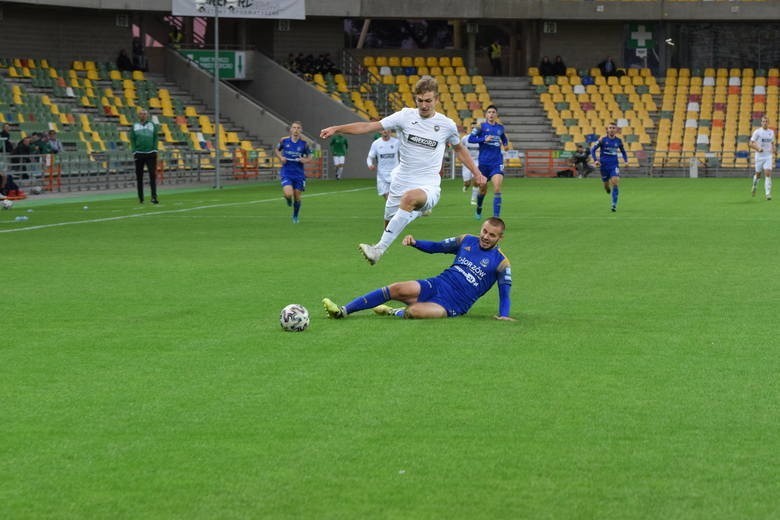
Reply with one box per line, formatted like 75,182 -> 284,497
418,235 -> 512,316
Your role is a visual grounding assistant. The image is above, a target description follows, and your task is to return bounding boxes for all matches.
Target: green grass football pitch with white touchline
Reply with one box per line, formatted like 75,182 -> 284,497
0,177 -> 780,520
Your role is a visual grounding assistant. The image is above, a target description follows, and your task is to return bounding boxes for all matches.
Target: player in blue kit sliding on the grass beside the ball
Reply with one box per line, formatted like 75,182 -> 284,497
322,217 -> 514,321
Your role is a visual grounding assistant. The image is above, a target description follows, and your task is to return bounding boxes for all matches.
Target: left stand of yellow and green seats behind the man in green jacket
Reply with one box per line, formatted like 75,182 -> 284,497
0,58 -> 275,189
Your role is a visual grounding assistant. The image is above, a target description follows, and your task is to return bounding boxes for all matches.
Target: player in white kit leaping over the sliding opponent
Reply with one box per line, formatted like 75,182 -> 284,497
320,76 -> 485,265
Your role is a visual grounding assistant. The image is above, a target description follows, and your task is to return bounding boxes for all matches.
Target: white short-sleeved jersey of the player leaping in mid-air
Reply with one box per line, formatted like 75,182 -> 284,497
380,108 -> 460,187
